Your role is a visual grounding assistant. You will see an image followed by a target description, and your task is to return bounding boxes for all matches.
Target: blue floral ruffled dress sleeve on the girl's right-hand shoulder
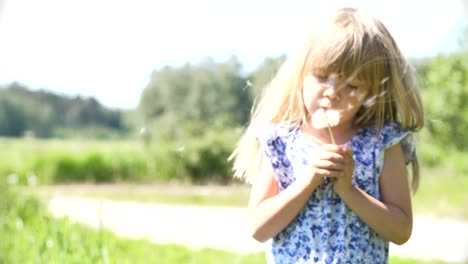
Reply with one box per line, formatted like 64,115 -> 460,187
380,123 -> 416,165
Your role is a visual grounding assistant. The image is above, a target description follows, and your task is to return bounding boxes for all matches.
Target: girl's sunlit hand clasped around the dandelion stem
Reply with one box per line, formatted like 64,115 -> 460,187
306,145 -> 352,186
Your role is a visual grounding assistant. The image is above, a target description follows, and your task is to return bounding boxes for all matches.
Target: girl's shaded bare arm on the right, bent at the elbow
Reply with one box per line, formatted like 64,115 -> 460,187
335,144 -> 413,245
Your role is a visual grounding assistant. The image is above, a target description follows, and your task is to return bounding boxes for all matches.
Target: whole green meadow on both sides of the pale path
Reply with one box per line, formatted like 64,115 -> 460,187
0,139 -> 468,264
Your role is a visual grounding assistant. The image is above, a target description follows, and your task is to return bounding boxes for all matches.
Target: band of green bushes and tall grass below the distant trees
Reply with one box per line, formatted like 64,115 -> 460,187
0,127 -> 241,184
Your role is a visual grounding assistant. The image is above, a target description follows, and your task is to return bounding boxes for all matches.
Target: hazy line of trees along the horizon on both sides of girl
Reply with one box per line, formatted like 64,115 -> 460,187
0,47 -> 468,150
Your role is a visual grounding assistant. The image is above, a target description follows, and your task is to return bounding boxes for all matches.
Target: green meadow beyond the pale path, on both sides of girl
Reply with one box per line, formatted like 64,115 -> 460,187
0,135 -> 468,219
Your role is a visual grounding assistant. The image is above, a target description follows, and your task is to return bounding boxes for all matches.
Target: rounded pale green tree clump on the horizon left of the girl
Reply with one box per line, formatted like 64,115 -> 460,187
139,57 -> 251,127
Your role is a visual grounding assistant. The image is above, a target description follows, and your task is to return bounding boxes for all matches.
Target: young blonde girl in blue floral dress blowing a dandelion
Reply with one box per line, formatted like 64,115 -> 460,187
232,8 -> 423,263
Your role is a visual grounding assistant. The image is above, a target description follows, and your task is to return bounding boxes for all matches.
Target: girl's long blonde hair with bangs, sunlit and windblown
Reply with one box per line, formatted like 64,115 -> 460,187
230,8 -> 424,190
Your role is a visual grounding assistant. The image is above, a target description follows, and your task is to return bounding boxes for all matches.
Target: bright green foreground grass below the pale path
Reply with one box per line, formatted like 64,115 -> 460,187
4,186 -> 464,264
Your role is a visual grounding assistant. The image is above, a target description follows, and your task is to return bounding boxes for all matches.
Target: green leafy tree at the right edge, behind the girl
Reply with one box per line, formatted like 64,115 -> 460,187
423,51 -> 468,151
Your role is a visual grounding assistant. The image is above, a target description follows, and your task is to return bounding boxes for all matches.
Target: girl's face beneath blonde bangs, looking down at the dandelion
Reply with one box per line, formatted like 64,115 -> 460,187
303,75 -> 367,128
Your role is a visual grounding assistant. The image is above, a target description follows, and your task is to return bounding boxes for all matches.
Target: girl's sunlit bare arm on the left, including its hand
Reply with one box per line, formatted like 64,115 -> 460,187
249,145 -> 344,242
